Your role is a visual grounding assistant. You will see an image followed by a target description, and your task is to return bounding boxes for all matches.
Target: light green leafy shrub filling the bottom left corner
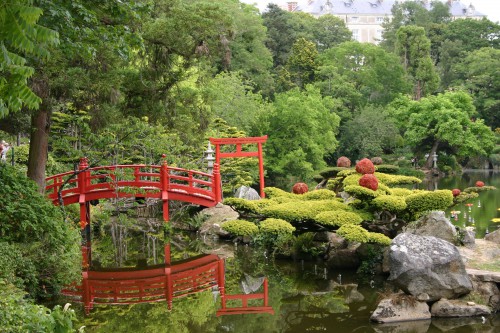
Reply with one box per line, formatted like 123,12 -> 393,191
0,279 -> 76,333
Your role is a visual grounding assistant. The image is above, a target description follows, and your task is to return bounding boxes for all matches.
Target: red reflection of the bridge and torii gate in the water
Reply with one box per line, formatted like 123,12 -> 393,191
63,244 -> 274,316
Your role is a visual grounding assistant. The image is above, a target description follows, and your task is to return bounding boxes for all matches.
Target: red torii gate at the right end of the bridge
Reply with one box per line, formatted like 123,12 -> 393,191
209,135 -> 267,198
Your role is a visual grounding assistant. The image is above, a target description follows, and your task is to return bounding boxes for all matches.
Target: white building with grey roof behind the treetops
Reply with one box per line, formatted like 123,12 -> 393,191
288,0 -> 486,44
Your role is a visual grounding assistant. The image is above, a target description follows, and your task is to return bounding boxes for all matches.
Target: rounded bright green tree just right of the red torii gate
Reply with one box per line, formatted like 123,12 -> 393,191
264,86 -> 340,183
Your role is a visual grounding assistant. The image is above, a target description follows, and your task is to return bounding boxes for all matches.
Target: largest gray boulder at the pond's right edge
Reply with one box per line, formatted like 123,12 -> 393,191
389,233 -> 472,301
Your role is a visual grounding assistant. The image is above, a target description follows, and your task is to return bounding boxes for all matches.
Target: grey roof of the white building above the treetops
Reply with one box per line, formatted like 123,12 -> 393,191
295,0 -> 486,17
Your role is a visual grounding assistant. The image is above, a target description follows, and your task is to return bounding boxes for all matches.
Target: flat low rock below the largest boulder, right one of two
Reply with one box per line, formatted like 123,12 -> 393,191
431,298 -> 491,317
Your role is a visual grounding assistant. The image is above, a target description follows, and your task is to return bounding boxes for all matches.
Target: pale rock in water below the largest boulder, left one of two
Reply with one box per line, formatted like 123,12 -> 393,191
370,294 -> 431,323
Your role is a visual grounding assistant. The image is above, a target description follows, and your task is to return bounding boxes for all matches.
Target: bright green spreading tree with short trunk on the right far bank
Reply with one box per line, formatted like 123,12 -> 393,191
389,91 -> 495,168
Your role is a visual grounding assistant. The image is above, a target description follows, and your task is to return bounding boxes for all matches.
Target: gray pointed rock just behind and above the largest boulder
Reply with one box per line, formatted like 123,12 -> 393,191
403,211 -> 457,244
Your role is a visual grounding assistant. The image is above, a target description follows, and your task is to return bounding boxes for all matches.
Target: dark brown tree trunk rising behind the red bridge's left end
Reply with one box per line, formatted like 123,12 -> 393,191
28,109 -> 50,193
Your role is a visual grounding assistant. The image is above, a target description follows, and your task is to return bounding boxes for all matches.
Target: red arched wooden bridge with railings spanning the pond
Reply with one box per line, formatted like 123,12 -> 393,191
45,158 -> 222,224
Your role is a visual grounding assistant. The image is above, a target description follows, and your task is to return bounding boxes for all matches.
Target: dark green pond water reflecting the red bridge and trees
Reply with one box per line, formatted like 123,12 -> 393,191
62,172 -> 500,333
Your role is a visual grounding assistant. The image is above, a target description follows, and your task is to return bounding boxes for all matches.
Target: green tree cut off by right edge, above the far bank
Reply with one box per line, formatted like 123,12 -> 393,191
452,47 -> 500,128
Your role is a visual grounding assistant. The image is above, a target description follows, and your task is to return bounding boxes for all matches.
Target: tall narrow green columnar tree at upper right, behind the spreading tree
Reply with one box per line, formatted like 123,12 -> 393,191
396,26 -> 439,100
